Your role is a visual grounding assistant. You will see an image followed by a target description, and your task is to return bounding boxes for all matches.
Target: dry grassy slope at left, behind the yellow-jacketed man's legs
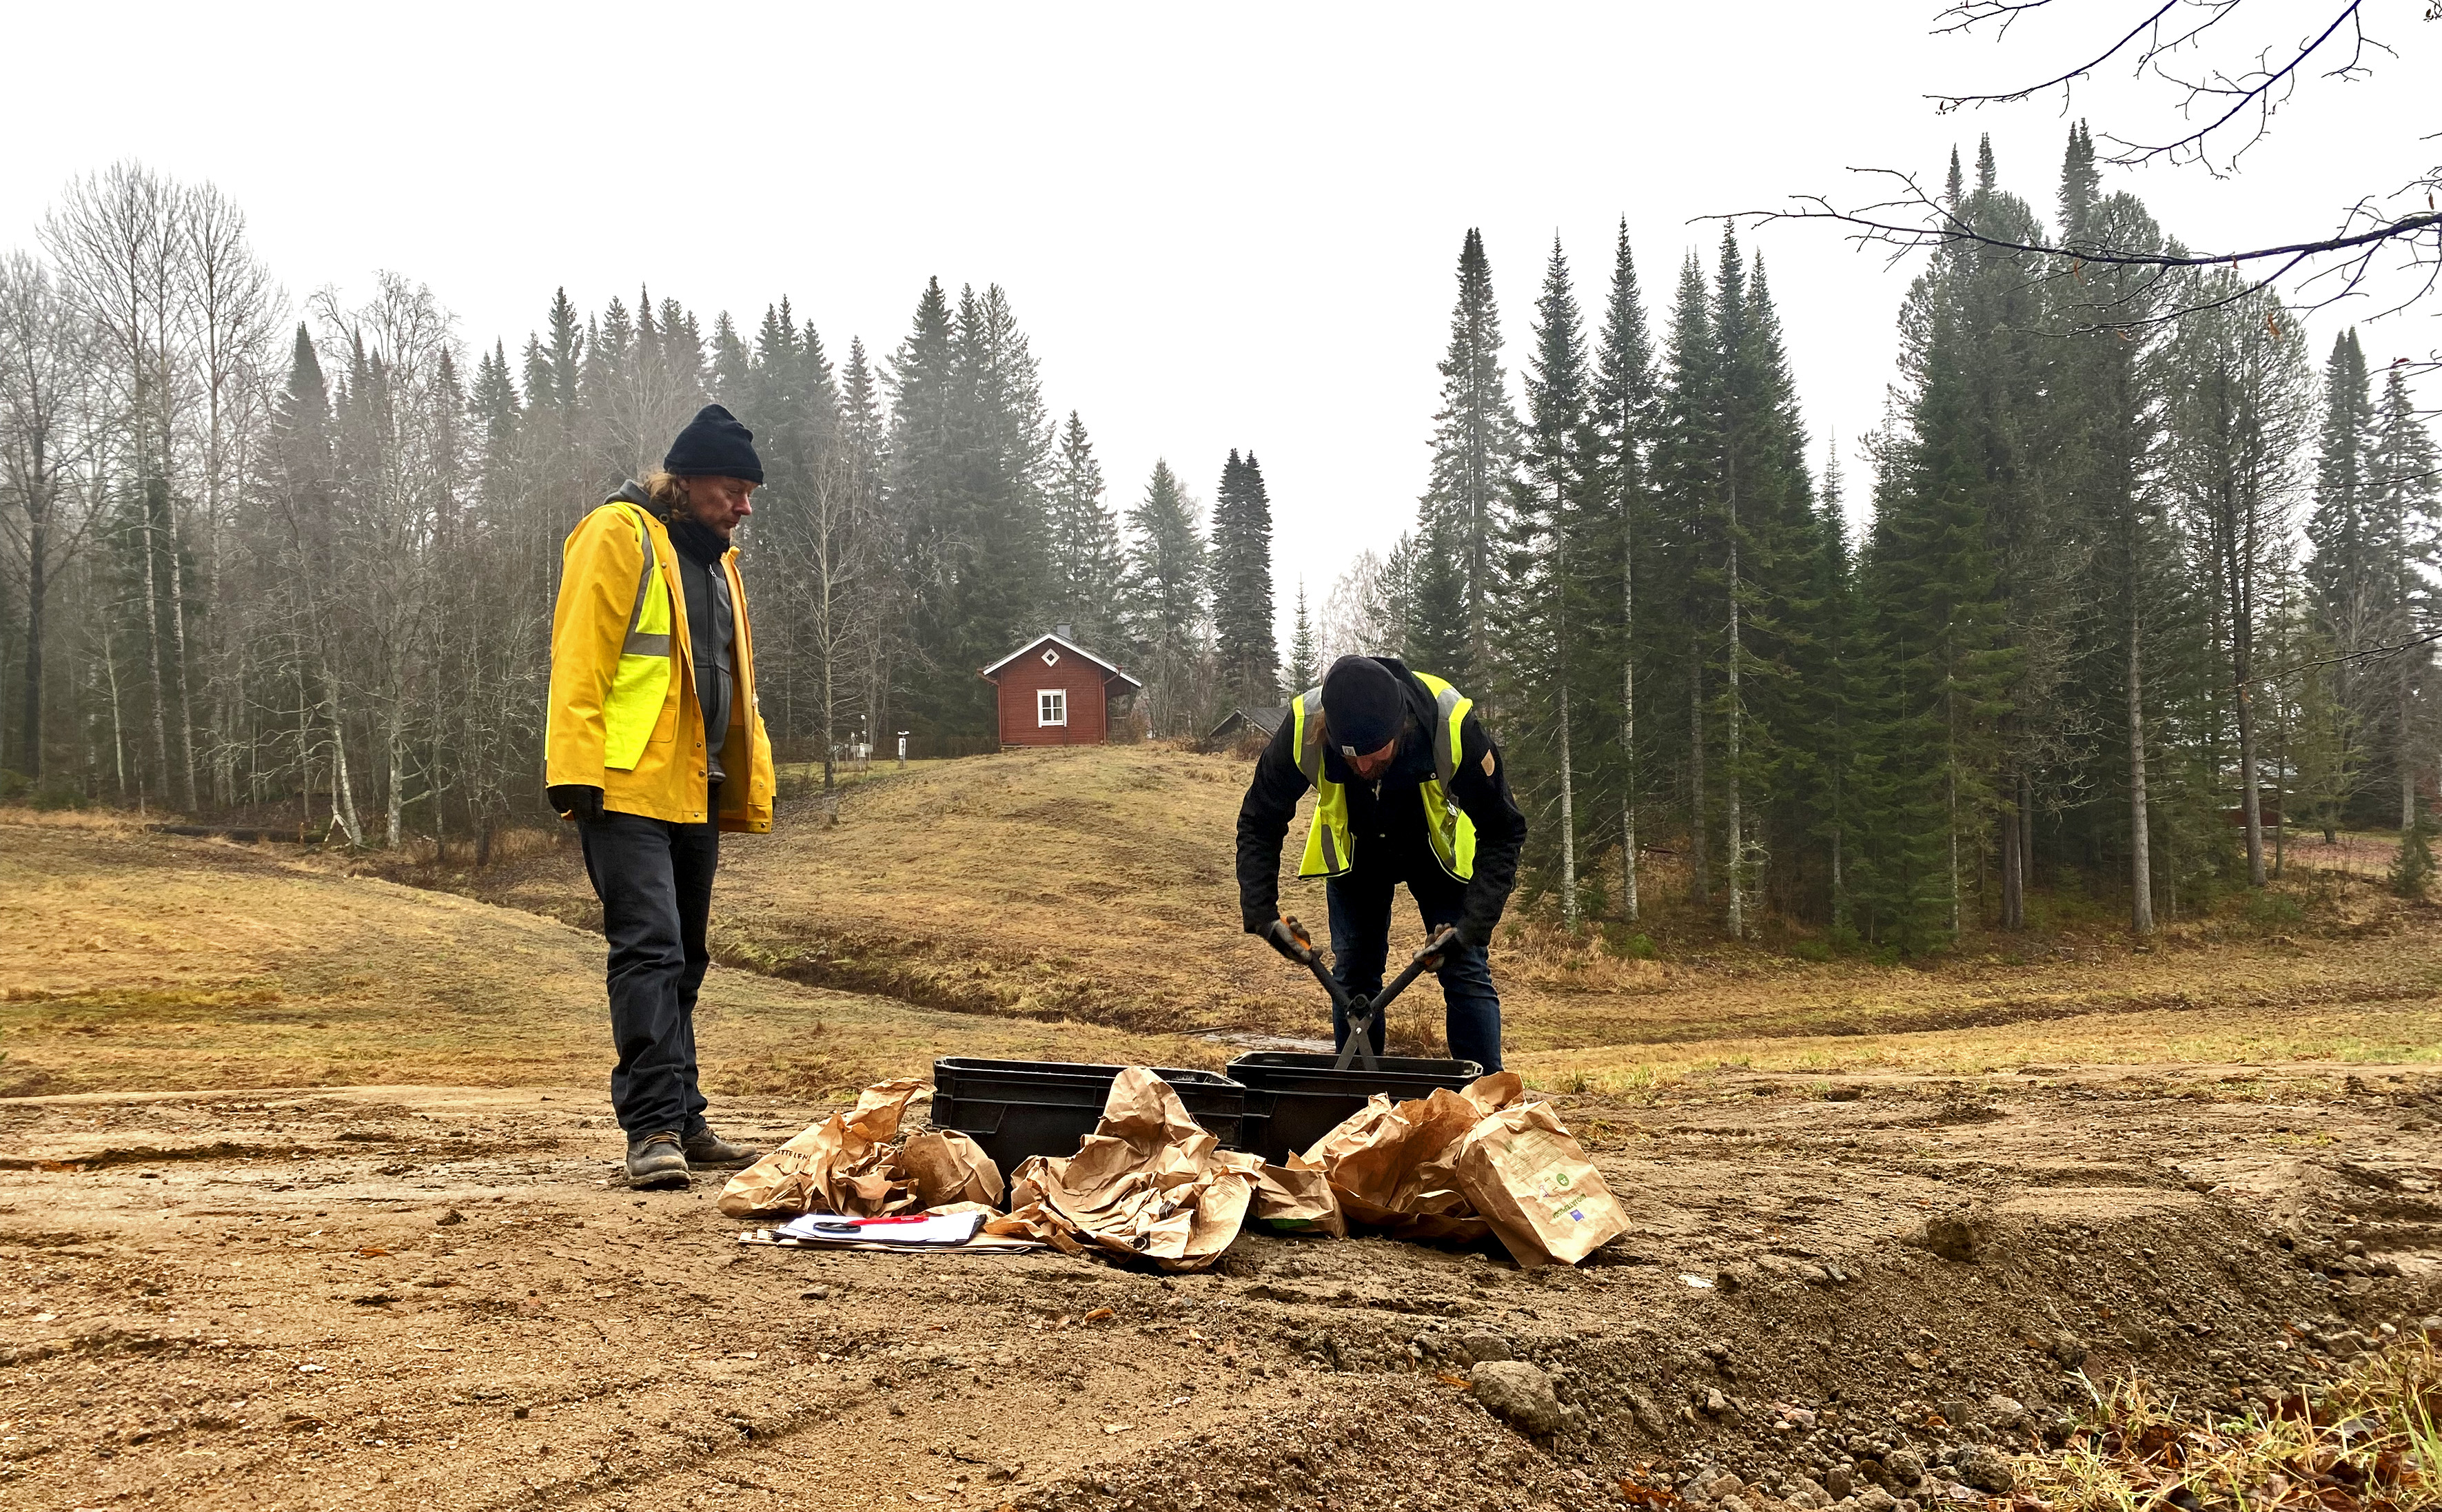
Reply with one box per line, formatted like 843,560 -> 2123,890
0,813 -> 1191,1096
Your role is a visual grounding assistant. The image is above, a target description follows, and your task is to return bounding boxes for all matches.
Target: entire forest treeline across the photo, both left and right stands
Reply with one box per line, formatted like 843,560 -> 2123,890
0,130 -> 2437,950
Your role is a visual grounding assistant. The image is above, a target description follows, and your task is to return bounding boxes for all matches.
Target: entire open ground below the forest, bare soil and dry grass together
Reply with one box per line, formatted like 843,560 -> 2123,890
0,753 -> 2442,1512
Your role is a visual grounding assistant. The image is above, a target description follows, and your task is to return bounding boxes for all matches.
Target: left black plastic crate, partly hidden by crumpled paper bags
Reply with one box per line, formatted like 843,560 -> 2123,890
933,1058 -> 1245,1180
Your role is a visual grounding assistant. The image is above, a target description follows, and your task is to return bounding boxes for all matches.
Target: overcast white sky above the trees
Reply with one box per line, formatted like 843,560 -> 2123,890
0,0 -> 2442,649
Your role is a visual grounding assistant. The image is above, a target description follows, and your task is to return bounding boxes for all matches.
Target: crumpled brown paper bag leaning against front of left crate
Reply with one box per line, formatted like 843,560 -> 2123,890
1008,1065 -> 1255,1270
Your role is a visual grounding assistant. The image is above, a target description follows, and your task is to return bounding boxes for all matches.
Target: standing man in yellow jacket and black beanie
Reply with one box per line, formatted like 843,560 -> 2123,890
545,405 -> 772,1187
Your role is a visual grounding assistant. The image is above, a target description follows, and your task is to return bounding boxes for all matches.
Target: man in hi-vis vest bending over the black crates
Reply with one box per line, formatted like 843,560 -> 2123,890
1238,657 -> 1526,1072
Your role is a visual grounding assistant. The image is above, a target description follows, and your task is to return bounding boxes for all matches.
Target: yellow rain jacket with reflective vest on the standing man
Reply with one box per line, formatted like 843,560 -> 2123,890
545,484 -> 772,835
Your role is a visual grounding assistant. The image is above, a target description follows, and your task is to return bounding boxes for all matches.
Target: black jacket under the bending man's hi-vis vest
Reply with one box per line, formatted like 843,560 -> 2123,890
1238,657 -> 1526,946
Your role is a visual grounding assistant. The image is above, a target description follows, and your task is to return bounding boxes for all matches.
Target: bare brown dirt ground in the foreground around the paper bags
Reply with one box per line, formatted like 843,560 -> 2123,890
0,1067 -> 2442,1512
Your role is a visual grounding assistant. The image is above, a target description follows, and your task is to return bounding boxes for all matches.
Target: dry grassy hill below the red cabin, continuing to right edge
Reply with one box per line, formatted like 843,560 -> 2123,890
371,745 -> 2442,1085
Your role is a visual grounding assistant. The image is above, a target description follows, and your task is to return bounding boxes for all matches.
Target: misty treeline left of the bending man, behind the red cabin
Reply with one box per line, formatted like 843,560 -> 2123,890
0,163 -> 1280,845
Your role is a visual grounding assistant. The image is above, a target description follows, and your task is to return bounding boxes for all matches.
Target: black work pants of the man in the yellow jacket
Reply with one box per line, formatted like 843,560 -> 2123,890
576,791 -> 720,1138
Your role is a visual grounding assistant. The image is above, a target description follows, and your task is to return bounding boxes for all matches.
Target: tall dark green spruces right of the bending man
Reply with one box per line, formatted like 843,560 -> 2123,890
1326,127 -> 2442,950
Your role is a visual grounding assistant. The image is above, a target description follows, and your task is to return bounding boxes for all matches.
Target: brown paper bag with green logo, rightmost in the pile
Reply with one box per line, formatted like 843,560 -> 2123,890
1458,1102 -> 1629,1268
